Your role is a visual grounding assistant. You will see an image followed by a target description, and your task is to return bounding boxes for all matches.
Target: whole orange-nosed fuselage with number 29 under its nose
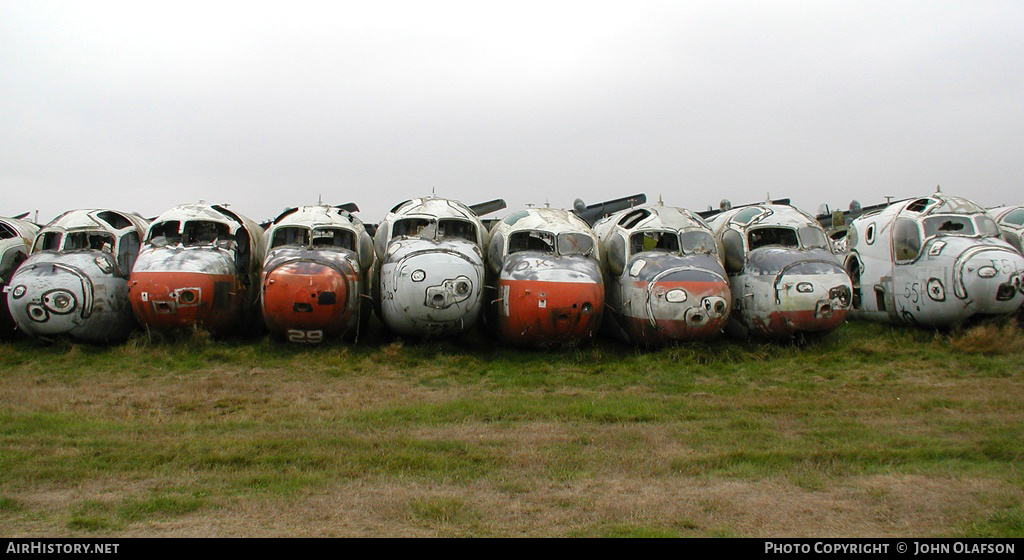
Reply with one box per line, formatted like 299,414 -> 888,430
260,206 -> 374,344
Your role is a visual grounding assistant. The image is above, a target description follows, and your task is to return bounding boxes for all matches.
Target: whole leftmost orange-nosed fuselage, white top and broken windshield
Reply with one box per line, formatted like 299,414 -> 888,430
129,204 -> 263,334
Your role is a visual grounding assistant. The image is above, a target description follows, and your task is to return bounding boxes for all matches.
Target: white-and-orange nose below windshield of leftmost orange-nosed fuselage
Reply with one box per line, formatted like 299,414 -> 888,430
128,245 -> 251,334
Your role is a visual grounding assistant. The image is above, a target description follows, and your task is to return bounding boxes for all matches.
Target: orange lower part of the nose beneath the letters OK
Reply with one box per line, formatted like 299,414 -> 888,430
498,279 -> 604,347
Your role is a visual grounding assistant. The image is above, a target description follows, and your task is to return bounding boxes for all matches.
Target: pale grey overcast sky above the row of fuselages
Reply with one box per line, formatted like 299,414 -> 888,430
0,0 -> 1024,222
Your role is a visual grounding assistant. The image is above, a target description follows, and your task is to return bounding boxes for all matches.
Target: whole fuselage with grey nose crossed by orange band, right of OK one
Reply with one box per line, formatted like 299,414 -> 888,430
594,205 -> 732,346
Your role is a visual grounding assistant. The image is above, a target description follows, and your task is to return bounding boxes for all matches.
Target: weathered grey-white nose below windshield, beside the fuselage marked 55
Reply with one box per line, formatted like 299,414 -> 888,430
731,248 -> 852,338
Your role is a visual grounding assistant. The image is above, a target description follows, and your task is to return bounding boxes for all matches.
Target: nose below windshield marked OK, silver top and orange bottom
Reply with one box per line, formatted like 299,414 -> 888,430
488,252 -> 604,347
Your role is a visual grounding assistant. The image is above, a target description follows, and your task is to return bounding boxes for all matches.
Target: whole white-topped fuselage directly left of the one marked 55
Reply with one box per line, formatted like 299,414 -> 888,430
710,204 -> 851,338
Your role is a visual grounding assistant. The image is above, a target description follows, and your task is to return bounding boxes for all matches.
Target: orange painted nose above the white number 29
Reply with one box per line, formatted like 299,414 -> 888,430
263,261 -> 351,336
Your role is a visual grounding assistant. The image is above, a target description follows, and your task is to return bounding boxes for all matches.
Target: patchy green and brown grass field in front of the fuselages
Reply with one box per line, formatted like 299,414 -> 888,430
0,317 -> 1024,537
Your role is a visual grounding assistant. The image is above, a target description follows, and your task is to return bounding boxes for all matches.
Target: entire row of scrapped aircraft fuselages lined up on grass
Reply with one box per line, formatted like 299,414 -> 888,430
0,193 -> 1024,347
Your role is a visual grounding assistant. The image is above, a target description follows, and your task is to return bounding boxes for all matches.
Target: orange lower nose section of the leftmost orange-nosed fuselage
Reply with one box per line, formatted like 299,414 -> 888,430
128,271 -> 239,333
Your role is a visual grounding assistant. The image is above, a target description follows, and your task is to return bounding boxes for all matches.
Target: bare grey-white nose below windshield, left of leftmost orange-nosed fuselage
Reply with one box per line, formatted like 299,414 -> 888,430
6,250 -> 136,343
